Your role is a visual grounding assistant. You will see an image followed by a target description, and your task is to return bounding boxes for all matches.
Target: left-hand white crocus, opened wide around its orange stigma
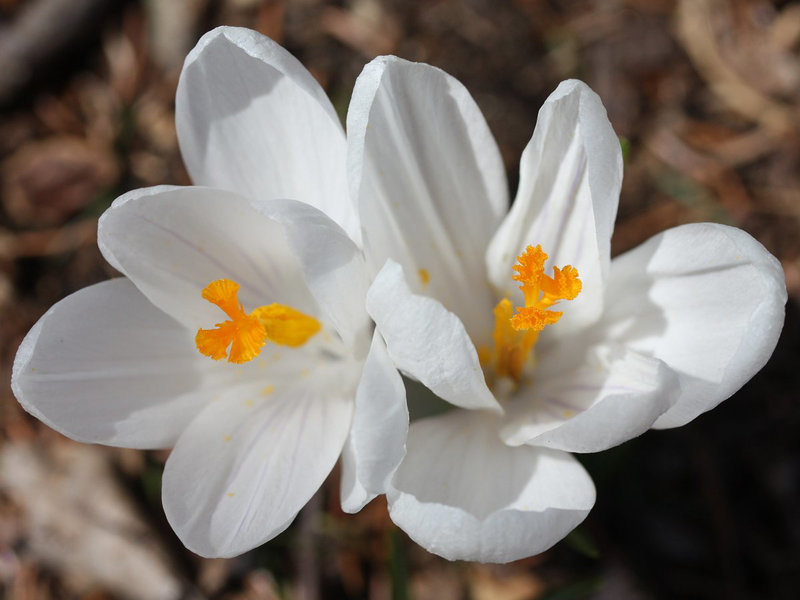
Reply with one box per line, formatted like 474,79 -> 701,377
12,28 -> 390,556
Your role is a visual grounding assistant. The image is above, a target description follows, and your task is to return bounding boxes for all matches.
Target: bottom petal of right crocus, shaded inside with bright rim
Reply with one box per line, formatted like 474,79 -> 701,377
387,411 -> 595,563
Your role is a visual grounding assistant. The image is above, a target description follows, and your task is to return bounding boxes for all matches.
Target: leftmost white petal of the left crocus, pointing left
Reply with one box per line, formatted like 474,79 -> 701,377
11,279 -> 216,448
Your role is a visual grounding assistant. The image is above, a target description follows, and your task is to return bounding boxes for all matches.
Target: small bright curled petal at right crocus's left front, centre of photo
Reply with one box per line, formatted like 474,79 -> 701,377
367,260 -> 500,410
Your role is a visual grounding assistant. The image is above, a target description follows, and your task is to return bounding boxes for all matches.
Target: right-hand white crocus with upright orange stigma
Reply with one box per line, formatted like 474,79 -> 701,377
342,57 -> 786,562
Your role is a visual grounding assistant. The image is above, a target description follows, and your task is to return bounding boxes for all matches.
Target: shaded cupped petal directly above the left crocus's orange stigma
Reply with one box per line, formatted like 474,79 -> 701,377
98,186 -> 319,332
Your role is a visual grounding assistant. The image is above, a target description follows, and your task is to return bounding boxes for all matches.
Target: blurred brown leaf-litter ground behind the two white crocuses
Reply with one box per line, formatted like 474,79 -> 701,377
0,0 -> 800,600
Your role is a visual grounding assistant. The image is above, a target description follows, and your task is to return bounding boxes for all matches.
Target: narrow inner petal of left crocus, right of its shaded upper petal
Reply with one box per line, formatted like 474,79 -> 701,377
253,200 -> 371,356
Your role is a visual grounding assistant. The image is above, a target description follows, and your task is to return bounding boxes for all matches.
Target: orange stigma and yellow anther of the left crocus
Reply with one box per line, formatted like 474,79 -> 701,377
194,279 -> 321,363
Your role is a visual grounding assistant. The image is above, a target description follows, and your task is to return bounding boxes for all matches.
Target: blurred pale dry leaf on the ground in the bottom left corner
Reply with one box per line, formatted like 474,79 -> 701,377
0,441 -> 182,600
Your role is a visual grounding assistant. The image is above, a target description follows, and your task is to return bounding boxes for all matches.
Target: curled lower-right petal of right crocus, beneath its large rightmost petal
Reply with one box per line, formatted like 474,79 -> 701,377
502,346 -> 680,452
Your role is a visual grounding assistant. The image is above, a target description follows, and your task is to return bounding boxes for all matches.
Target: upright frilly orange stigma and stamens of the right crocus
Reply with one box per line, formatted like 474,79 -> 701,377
481,246 -> 581,383
